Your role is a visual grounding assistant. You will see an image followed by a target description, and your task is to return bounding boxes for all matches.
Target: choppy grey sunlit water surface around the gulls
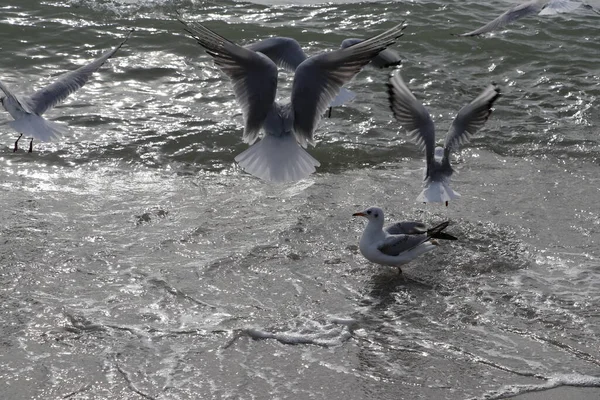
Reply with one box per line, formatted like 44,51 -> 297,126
0,0 -> 600,399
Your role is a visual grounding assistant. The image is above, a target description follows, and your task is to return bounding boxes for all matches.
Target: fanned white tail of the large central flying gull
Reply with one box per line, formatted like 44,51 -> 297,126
235,134 -> 321,183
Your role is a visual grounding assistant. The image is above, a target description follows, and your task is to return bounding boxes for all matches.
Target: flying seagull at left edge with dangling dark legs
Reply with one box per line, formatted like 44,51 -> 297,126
0,30 -> 133,153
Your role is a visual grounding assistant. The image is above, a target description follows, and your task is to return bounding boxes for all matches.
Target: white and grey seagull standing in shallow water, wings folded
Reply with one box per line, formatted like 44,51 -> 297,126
352,207 -> 458,273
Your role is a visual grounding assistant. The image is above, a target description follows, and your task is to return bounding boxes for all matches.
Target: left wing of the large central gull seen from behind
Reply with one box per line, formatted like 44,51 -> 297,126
178,19 -> 277,144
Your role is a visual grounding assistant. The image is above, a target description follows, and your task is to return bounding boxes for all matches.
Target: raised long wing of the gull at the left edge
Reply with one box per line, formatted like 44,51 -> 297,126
26,30 -> 133,115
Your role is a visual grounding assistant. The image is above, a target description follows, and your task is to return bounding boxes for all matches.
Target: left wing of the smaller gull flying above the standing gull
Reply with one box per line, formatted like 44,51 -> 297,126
388,70 -> 435,178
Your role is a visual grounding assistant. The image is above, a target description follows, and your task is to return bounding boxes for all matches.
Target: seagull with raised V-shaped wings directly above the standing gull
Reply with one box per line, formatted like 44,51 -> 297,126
388,70 -> 500,206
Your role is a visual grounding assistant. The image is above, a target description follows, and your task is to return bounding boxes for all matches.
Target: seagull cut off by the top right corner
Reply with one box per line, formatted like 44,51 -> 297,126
459,0 -> 600,36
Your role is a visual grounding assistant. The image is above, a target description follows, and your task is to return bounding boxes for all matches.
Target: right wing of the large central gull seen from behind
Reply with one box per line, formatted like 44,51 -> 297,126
292,23 -> 405,146
